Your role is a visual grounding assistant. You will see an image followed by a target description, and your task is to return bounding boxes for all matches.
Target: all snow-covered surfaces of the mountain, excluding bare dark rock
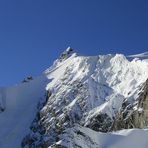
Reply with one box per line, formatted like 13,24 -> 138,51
0,48 -> 148,148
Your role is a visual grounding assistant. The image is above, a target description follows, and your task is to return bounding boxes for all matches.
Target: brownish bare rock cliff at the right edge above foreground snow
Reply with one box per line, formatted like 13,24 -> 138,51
112,79 -> 148,130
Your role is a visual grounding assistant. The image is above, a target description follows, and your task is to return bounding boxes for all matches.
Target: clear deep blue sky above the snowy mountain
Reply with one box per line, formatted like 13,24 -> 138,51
0,0 -> 148,86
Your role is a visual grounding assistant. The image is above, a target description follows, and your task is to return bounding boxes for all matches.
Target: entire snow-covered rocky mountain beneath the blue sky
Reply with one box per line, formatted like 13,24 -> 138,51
0,47 -> 148,148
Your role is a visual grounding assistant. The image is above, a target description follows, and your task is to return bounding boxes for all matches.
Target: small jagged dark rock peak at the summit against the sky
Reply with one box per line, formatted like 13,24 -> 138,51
59,47 -> 74,62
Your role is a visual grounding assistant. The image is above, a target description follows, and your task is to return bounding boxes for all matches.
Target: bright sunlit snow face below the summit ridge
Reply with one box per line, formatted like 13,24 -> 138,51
45,54 -> 148,118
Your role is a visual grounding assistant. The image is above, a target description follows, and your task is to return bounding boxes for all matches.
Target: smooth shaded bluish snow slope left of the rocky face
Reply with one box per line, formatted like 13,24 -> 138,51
0,76 -> 49,148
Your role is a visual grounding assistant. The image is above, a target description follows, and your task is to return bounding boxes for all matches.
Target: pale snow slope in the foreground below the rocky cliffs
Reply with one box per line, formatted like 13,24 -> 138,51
55,125 -> 148,148
